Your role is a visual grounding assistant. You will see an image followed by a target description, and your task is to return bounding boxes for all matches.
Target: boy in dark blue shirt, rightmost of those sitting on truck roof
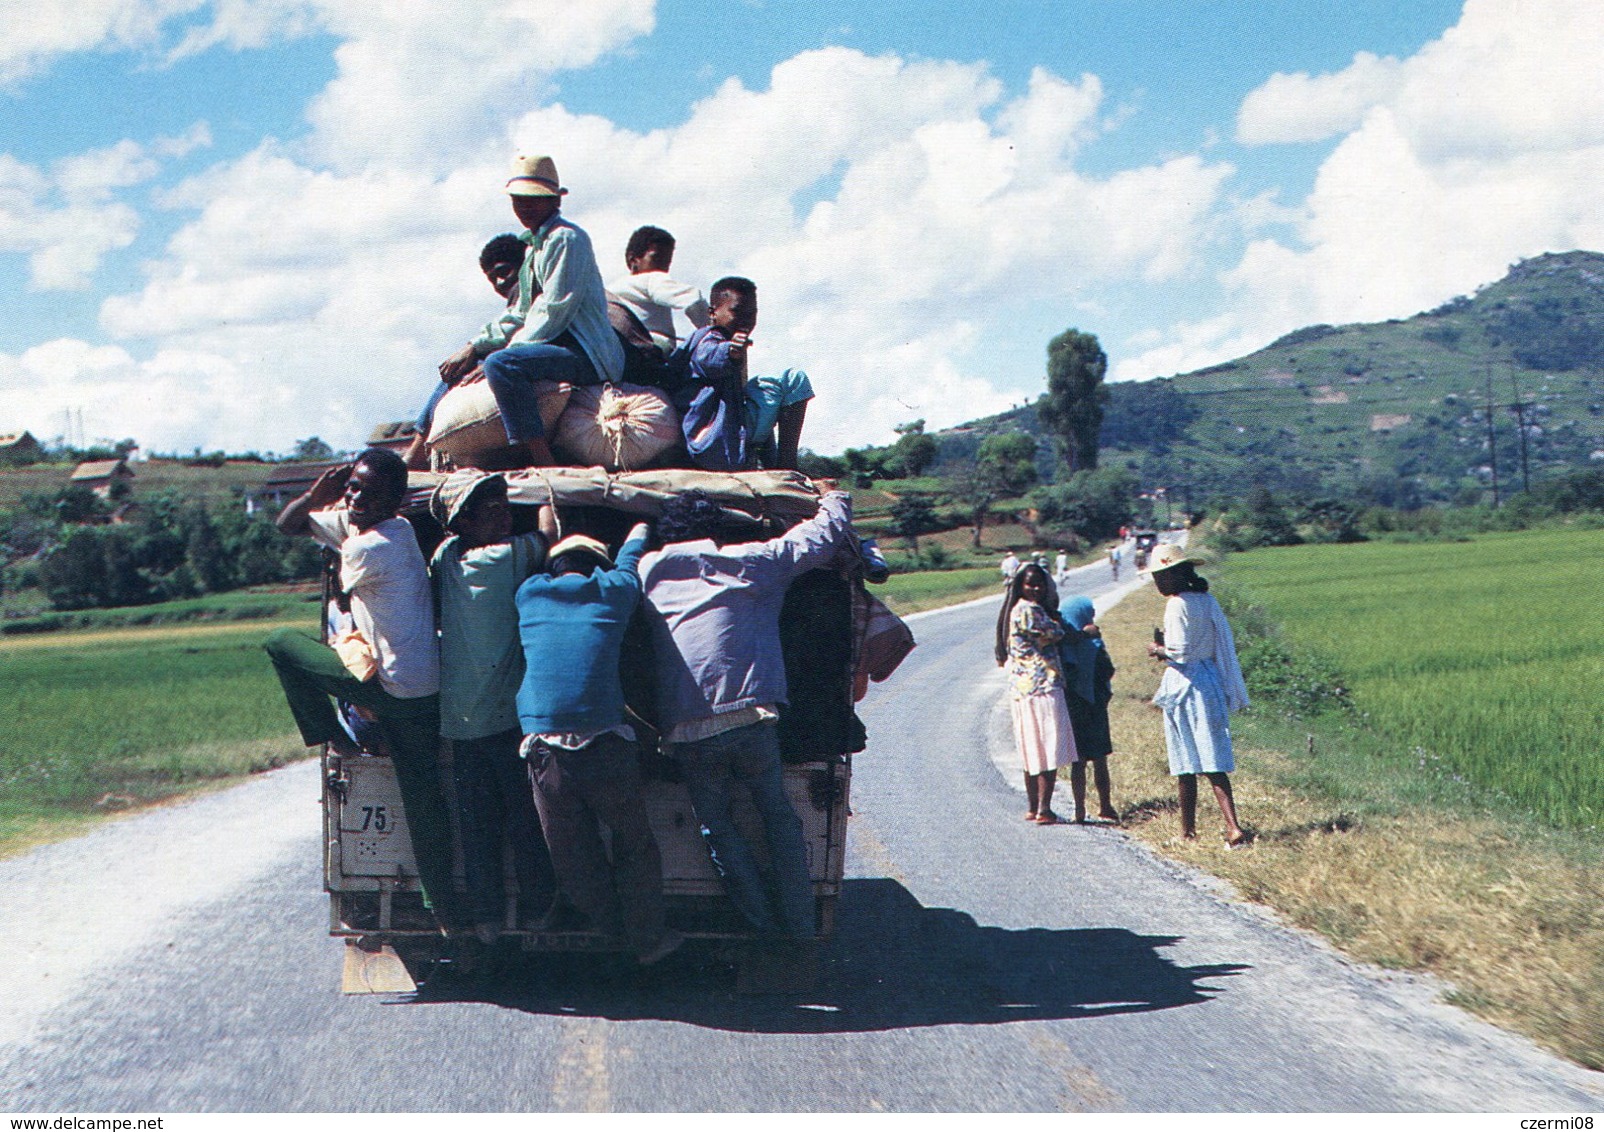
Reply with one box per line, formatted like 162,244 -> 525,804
677,276 -> 813,471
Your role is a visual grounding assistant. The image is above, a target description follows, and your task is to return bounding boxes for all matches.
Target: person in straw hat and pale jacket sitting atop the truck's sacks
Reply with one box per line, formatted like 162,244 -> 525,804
439,156 -> 624,467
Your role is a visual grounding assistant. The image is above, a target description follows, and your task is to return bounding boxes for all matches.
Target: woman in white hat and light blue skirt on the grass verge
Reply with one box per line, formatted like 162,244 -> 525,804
1147,544 -> 1251,848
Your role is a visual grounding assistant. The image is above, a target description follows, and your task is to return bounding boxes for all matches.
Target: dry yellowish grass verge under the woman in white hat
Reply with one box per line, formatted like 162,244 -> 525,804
1102,590 -> 1604,1069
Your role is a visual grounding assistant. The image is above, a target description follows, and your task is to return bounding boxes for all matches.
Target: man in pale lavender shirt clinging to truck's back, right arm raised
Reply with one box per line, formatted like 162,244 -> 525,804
642,491 -> 852,940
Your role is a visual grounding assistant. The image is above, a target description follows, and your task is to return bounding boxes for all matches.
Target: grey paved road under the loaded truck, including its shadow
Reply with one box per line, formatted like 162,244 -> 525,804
0,554 -> 1604,1113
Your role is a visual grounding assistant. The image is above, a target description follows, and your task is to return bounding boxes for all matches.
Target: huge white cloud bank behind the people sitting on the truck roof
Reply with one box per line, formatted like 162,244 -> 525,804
87,48 -> 1230,451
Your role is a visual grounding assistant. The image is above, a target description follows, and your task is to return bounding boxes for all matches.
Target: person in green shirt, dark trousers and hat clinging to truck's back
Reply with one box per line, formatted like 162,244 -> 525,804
430,468 -> 557,943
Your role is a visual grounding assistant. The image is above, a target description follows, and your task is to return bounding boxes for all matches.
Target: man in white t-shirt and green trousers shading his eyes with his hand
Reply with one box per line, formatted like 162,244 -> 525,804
265,449 -> 457,922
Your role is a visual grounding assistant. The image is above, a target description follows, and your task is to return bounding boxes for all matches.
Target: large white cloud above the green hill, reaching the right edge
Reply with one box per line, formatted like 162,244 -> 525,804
1118,0 -> 1604,377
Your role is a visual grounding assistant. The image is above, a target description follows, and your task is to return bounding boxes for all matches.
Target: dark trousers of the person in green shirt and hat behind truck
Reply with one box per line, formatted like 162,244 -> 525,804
451,730 -> 557,924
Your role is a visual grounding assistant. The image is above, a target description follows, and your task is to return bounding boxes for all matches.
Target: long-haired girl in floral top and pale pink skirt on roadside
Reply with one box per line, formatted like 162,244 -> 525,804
996,564 -> 1075,826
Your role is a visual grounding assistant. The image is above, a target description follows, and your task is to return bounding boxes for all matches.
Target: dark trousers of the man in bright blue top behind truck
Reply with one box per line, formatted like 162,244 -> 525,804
529,734 -> 664,954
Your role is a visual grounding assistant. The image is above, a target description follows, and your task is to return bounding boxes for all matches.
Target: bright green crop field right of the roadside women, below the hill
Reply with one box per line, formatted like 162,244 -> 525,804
1229,531 -> 1604,826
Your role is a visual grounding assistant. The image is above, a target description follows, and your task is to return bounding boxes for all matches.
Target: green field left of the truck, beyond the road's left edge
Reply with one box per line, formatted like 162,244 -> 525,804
0,606 -> 316,848
